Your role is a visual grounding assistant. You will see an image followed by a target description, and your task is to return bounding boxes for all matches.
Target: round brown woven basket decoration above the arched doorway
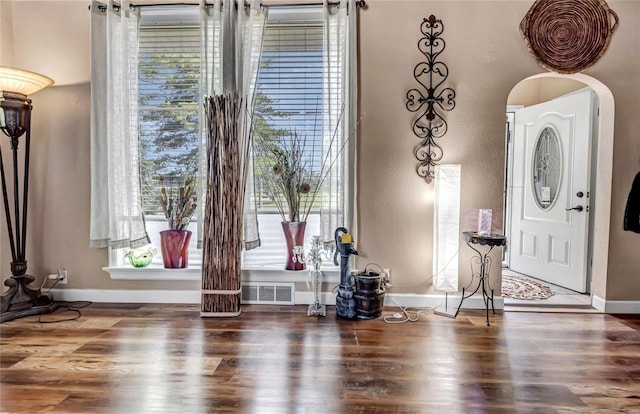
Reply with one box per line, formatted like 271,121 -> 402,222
520,0 -> 618,73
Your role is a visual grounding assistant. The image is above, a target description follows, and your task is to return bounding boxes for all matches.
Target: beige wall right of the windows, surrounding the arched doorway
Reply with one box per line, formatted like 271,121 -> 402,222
358,0 -> 640,300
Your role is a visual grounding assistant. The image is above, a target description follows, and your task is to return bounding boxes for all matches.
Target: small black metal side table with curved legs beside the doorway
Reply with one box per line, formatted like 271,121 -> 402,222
458,231 -> 507,326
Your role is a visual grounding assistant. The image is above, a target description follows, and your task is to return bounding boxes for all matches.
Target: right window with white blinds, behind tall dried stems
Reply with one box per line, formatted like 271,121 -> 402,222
243,9 -> 324,268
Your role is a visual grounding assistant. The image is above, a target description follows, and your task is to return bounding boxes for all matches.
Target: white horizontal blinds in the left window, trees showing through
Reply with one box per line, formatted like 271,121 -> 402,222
138,22 -> 200,214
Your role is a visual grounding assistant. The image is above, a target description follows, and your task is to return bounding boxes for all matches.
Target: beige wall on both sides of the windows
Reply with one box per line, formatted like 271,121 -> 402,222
1,0 -> 640,300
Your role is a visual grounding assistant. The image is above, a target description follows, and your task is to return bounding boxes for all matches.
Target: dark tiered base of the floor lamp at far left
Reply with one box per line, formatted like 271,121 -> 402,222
0,275 -> 58,323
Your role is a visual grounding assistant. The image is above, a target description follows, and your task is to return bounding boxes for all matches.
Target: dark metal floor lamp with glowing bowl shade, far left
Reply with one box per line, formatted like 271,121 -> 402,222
0,66 -> 57,322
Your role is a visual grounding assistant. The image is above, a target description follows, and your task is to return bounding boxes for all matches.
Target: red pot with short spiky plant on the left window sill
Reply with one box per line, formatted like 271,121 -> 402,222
160,176 -> 196,269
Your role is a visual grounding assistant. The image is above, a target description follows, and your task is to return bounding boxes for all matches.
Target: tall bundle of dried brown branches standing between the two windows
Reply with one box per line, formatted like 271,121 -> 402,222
201,95 -> 251,316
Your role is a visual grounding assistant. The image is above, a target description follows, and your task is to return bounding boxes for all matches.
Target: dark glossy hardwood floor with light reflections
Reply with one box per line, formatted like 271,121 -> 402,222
0,304 -> 640,414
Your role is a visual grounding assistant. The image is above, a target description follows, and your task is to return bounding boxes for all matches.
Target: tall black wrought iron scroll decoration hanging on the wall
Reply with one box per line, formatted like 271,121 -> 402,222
406,15 -> 456,183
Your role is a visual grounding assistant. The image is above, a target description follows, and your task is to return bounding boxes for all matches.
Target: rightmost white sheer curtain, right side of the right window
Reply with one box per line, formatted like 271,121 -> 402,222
320,0 -> 358,244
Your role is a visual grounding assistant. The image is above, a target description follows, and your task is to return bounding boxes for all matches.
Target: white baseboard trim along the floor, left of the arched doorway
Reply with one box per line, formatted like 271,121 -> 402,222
51,289 -> 504,309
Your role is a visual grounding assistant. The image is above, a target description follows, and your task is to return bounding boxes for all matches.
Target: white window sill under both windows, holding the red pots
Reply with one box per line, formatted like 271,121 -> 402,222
102,264 -> 340,283
